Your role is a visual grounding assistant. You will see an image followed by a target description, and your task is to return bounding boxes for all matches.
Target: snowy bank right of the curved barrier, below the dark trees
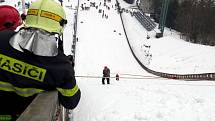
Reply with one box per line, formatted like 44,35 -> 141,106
119,0 -> 215,74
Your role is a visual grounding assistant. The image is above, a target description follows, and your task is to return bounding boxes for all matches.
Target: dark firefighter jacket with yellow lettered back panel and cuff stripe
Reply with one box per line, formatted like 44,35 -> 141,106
0,30 -> 81,109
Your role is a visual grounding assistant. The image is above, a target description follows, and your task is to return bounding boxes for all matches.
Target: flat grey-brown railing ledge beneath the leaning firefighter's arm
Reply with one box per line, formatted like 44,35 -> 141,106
17,91 -> 64,121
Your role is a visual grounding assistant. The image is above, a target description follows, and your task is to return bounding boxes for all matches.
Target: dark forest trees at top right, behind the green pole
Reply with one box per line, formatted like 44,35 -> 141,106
153,0 -> 215,46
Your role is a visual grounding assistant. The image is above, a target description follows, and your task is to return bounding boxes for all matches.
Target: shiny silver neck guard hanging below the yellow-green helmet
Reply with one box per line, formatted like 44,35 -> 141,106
10,29 -> 58,56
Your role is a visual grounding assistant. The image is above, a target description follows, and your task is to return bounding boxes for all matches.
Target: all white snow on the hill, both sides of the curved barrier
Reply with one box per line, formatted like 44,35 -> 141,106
1,0 -> 215,121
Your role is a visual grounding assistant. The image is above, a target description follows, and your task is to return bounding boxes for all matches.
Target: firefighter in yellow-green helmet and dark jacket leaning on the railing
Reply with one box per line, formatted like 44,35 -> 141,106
0,0 -> 81,119
